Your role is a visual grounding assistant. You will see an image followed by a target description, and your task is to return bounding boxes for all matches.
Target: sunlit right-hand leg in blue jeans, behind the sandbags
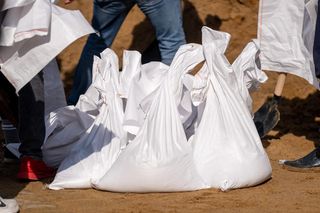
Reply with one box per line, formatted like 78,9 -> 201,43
136,0 -> 186,65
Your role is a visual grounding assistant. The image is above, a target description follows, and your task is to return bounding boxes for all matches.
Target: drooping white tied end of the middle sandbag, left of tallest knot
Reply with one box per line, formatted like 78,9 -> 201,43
166,43 -> 205,104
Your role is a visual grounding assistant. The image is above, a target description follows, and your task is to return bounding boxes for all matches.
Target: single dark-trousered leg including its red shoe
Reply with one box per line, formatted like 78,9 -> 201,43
18,71 -> 55,180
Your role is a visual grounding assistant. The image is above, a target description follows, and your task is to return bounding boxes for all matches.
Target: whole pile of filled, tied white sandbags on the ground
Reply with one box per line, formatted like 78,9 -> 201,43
44,27 -> 271,192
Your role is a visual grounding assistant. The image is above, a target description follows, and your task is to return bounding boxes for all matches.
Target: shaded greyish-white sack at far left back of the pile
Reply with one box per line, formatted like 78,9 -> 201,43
42,56 -> 115,168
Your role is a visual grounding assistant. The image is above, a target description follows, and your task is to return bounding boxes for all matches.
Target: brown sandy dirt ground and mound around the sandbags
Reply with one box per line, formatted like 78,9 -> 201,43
0,0 -> 320,213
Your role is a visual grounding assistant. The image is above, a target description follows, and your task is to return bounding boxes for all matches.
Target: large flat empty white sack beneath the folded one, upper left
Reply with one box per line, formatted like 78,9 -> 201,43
0,0 -> 94,91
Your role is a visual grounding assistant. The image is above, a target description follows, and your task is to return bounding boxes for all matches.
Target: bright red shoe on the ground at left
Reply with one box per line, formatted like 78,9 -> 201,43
18,156 -> 55,180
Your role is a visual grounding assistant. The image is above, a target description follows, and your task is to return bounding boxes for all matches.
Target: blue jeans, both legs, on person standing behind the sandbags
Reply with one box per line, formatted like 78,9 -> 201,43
68,0 -> 186,105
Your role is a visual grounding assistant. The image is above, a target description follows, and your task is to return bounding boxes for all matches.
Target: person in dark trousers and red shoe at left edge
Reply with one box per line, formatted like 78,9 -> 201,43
0,71 -> 55,180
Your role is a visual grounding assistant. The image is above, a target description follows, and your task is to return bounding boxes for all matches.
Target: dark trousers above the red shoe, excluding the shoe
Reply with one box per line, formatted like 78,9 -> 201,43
0,71 -> 46,158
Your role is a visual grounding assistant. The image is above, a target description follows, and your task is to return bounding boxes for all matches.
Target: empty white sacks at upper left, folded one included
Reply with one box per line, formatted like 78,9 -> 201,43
0,0 -> 94,91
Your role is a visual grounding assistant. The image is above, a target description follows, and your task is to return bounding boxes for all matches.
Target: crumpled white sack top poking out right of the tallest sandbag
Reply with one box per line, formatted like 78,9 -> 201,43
232,41 -> 268,116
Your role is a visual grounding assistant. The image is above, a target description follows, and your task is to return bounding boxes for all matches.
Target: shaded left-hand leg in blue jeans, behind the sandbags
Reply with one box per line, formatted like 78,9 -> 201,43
68,0 -> 134,105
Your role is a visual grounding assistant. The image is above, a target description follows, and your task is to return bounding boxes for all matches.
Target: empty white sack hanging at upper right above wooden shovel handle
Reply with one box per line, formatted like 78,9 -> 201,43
258,0 -> 319,89
